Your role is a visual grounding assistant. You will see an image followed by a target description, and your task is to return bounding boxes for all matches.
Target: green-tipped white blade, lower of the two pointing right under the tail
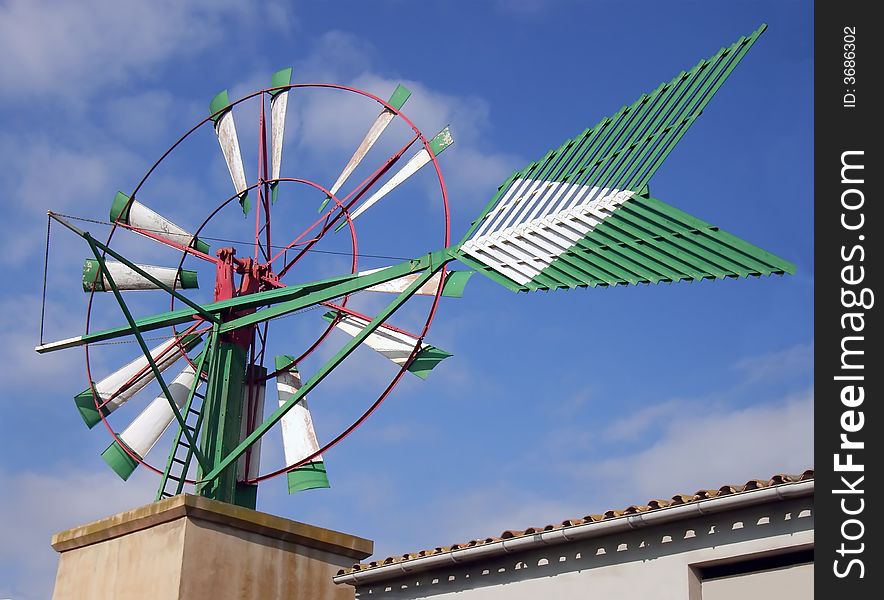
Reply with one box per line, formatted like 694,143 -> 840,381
322,311 -> 452,379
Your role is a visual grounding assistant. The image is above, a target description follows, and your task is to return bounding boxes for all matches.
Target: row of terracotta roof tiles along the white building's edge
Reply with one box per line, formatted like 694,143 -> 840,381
337,469 -> 814,577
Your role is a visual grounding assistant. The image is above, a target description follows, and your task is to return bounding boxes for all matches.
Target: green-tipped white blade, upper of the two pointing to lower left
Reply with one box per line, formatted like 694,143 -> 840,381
74,334 -> 202,429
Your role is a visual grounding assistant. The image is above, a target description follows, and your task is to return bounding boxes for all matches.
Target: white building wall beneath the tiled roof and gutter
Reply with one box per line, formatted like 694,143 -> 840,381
357,496 -> 814,600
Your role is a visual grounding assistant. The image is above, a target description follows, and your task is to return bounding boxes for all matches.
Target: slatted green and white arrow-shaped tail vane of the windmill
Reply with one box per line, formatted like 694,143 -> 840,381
454,26 -> 795,291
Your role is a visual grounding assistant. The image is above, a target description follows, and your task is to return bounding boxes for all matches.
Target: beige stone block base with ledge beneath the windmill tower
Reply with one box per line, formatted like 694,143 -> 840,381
52,494 -> 374,600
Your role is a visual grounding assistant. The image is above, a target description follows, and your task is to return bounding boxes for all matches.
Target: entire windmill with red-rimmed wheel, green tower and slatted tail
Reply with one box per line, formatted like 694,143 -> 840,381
36,25 -> 794,507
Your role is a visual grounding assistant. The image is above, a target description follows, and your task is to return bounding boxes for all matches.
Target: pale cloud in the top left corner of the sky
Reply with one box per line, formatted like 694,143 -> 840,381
0,0 -> 249,101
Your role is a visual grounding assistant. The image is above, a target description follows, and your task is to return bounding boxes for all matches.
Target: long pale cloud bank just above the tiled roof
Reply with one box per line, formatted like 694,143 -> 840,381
360,392 -> 813,557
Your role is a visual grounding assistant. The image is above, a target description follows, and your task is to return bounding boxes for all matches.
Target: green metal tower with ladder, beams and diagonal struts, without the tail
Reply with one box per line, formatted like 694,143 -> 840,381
51,214 -> 455,507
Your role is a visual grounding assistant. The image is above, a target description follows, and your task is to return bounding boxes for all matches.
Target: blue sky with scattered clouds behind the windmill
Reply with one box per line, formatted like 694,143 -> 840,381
0,0 -> 813,598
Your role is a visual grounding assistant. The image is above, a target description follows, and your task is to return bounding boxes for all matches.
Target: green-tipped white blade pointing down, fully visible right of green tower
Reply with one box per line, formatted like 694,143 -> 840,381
275,355 -> 329,494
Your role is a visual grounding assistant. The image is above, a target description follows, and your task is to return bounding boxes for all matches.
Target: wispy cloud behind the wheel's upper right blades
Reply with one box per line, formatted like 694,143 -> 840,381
276,31 -> 526,219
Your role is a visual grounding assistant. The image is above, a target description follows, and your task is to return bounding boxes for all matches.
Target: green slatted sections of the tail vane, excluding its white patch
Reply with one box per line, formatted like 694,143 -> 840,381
454,25 -> 794,291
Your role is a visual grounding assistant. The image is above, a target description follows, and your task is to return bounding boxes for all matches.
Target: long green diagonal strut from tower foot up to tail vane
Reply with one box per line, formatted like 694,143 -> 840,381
203,264 -> 450,482
